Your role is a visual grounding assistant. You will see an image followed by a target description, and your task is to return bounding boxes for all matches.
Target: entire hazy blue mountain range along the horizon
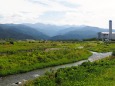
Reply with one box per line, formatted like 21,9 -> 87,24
0,23 -> 112,40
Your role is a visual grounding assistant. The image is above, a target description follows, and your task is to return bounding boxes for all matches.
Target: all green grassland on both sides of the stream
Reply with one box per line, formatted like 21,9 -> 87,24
0,40 -> 115,86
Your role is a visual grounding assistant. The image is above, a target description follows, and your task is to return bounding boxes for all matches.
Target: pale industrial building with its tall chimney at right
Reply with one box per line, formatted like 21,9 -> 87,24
98,20 -> 115,41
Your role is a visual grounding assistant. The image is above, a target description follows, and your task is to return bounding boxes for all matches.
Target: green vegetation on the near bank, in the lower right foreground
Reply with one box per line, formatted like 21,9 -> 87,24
24,57 -> 115,86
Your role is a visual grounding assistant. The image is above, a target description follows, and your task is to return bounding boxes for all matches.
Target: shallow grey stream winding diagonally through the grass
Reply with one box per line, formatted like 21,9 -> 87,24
0,52 -> 112,86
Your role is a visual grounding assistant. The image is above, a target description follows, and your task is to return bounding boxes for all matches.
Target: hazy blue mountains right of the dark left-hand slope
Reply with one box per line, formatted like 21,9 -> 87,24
25,23 -> 111,40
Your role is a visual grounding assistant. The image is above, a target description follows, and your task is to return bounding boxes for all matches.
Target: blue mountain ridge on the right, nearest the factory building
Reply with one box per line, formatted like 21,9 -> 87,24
51,26 -> 108,40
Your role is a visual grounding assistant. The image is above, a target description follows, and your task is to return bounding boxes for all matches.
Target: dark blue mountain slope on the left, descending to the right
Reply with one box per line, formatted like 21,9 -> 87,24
0,24 -> 49,39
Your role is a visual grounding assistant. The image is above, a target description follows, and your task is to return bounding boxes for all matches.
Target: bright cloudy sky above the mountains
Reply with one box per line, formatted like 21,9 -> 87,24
0,0 -> 115,28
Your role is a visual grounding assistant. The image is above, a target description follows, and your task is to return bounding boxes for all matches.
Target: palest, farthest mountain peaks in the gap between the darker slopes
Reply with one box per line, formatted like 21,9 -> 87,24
24,23 -> 70,37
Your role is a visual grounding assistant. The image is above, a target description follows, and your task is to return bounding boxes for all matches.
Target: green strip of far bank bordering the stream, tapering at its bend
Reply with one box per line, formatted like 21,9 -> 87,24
0,48 -> 92,77
